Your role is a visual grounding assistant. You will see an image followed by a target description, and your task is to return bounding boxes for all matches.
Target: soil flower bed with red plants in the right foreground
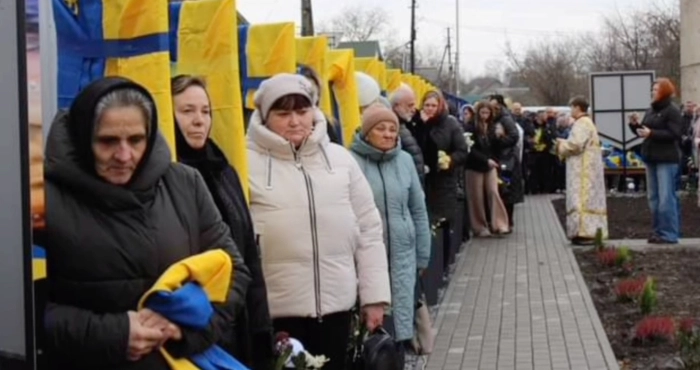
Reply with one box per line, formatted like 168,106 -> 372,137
574,246 -> 700,370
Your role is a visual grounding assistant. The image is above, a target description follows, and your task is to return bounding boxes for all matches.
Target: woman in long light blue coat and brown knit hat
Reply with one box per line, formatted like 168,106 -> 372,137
352,104 -> 430,348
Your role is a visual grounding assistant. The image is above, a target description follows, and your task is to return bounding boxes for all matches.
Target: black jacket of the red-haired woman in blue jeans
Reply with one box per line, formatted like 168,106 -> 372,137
630,98 -> 683,163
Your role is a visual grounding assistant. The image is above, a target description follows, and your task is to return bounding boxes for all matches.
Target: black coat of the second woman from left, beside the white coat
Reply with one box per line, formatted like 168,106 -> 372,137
175,137 -> 273,370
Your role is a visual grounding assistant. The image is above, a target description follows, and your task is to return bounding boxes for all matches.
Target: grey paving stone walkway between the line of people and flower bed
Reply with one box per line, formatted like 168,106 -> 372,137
427,196 -> 619,370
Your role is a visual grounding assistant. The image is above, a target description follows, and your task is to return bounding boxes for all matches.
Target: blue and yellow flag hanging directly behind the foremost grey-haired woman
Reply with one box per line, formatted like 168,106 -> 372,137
52,0 -> 175,155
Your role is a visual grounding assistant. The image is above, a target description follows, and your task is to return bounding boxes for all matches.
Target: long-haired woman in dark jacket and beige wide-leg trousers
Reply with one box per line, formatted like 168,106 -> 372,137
465,102 -> 509,237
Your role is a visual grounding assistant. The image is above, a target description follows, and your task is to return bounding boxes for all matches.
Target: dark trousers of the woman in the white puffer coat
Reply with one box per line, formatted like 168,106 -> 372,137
272,311 -> 351,370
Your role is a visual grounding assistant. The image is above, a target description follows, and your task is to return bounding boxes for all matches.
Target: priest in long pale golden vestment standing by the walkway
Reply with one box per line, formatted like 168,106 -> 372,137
556,97 -> 608,245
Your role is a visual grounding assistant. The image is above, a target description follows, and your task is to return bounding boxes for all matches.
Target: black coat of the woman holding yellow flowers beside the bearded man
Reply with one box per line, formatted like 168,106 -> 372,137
412,113 -> 467,222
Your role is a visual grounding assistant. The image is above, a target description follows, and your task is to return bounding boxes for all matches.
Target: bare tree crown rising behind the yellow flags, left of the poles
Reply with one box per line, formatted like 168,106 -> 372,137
319,5 -> 390,41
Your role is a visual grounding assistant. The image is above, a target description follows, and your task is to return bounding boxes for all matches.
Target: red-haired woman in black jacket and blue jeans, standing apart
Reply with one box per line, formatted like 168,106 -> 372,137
630,78 -> 683,244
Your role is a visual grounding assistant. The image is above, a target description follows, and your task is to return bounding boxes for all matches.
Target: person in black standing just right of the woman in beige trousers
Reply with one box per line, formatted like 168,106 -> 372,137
491,100 -> 525,232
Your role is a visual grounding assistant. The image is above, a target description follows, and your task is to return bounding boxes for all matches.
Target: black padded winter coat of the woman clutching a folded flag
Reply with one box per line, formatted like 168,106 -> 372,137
44,112 -> 250,370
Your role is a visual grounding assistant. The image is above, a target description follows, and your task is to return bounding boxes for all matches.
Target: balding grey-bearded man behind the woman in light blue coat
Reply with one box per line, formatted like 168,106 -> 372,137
391,85 -> 425,182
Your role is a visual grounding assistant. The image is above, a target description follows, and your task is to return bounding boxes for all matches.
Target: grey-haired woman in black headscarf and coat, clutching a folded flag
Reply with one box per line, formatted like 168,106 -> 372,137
44,77 -> 249,370
